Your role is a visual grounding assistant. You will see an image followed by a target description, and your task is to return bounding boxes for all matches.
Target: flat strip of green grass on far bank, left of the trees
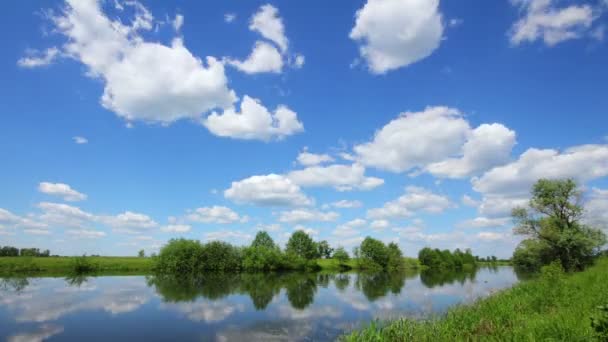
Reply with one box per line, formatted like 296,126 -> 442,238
0,257 -> 153,274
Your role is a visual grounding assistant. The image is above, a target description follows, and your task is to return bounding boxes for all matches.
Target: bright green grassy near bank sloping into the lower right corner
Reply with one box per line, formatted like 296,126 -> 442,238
343,258 -> 608,341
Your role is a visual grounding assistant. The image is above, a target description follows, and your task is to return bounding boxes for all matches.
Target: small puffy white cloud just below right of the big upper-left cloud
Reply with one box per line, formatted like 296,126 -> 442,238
203,95 -> 304,141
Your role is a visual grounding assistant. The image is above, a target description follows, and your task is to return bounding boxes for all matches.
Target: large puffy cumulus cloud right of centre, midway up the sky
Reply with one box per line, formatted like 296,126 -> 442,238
354,107 -> 515,178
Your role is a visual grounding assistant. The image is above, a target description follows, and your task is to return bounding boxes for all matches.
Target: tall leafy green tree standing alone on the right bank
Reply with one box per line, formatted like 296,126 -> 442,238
512,179 -> 606,271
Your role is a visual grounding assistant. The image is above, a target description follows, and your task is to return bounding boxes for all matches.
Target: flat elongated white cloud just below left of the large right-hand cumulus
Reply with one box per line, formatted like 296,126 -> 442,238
287,164 -> 384,191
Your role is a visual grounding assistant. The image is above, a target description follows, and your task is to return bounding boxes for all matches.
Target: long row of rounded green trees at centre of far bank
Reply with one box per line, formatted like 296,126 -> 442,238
154,230 -> 404,274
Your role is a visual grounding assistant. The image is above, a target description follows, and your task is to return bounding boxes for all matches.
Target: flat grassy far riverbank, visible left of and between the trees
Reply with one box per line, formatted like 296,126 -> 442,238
0,256 -> 421,274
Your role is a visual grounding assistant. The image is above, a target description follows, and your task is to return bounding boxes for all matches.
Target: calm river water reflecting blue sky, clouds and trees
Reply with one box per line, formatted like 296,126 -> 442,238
0,266 -> 518,342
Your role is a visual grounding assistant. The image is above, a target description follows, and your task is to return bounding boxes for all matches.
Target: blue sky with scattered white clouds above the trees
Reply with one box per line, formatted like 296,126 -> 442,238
0,0 -> 608,257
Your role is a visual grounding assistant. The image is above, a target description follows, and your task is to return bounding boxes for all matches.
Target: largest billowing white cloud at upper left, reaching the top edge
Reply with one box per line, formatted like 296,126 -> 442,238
29,0 -> 236,124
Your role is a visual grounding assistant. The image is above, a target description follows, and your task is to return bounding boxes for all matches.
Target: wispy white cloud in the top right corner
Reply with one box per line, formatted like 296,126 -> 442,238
509,0 -> 598,46
